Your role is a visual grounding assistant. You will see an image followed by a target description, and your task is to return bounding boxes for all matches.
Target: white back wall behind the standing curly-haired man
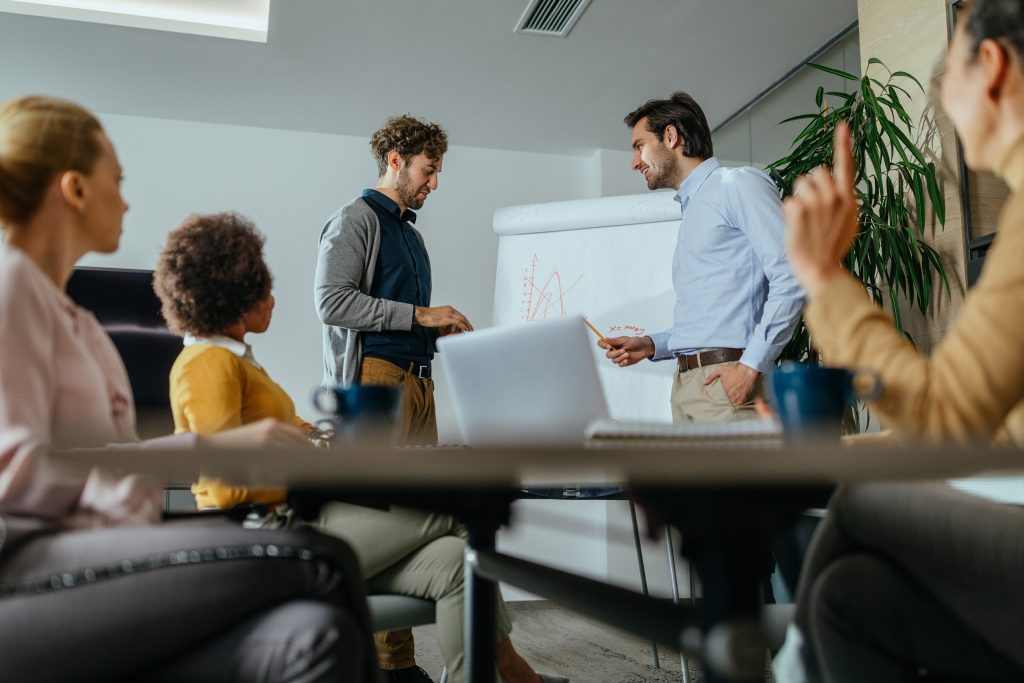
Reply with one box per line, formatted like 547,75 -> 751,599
84,115 -> 593,441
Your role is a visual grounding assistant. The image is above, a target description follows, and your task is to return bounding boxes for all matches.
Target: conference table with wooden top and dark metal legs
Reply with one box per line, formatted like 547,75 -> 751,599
54,440 -> 1024,683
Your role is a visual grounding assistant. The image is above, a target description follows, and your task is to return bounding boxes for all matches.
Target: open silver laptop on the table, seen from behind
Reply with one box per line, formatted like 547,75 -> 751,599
437,316 -> 608,445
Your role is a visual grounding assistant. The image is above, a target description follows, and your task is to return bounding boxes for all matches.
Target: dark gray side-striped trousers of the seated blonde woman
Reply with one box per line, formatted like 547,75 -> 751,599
0,521 -> 377,683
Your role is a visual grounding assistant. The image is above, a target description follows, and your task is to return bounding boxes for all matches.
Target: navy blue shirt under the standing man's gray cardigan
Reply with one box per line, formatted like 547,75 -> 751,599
362,189 -> 436,366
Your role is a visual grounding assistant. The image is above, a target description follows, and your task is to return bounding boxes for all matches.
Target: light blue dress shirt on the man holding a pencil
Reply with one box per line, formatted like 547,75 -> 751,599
650,157 -> 804,373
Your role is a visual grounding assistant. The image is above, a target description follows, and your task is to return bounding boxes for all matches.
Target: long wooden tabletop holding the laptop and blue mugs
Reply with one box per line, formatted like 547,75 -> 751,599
54,443 -> 1024,488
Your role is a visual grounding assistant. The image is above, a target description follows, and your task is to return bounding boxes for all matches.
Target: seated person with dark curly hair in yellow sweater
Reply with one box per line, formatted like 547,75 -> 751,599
154,213 -> 567,683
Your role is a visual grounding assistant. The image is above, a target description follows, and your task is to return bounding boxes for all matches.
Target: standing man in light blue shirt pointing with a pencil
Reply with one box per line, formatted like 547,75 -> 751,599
601,92 -> 804,422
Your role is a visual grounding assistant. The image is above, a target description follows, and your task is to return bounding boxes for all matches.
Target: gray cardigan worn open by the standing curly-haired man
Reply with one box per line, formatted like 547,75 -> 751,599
313,197 -> 430,386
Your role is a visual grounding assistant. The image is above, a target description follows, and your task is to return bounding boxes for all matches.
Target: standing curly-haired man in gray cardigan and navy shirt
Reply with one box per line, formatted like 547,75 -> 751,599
314,115 -> 473,458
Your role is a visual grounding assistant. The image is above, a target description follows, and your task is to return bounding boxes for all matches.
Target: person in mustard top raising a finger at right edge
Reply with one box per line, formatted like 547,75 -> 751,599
776,0 -> 1024,683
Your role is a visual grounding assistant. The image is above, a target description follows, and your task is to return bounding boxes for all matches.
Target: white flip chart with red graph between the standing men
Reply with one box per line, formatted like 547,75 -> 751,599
494,193 -> 680,422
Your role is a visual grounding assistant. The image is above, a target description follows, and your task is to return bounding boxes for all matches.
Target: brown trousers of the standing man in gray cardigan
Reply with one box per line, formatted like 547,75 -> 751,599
359,357 -> 437,445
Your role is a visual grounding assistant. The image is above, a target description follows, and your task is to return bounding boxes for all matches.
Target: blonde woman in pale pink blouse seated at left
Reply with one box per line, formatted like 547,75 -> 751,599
0,97 -> 376,683
